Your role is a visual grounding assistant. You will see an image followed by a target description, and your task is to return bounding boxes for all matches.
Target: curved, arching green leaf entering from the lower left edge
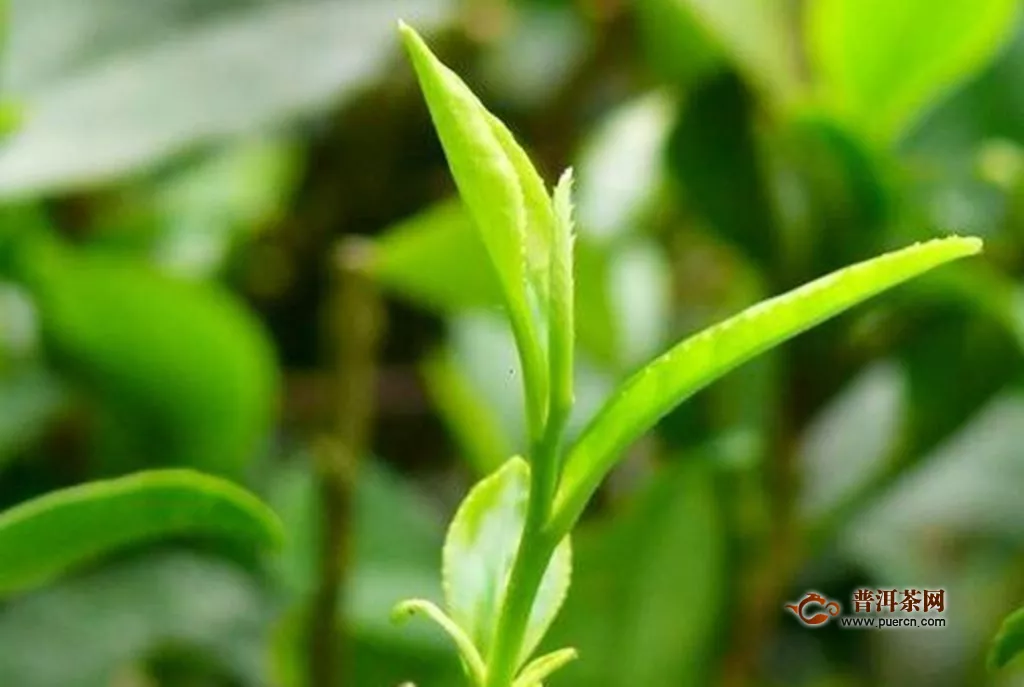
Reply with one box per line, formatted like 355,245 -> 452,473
0,470 -> 281,595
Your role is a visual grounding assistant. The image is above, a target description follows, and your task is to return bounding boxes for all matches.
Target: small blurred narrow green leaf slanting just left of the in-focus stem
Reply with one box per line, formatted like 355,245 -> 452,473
420,349 -> 511,475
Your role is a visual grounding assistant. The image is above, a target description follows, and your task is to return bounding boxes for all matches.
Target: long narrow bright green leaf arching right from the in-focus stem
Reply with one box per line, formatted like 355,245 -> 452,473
554,237 -> 981,531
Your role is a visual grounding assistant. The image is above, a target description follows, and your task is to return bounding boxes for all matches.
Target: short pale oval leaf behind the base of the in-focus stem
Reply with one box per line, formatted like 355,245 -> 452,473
443,457 -> 571,660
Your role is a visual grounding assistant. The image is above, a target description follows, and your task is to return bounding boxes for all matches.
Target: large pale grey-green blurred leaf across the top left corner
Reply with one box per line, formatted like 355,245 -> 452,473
0,0 -> 444,195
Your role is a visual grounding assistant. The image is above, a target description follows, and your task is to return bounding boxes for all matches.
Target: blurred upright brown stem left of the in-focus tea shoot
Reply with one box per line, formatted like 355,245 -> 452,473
309,239 -> 383,687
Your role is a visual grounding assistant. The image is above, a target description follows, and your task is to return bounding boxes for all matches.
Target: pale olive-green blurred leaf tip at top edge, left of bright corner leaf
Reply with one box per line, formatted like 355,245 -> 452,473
675,0 -> 801,102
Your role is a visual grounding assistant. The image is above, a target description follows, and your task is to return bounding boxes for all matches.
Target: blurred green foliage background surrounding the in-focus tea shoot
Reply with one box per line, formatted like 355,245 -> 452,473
6,0 -> 1024,687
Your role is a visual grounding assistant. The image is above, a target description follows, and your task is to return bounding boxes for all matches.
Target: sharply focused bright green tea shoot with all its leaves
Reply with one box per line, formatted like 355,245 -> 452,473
395,25 -> 981,687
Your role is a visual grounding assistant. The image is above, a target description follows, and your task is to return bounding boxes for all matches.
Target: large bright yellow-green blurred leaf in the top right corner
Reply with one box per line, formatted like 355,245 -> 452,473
806,0 -> 1019,143
